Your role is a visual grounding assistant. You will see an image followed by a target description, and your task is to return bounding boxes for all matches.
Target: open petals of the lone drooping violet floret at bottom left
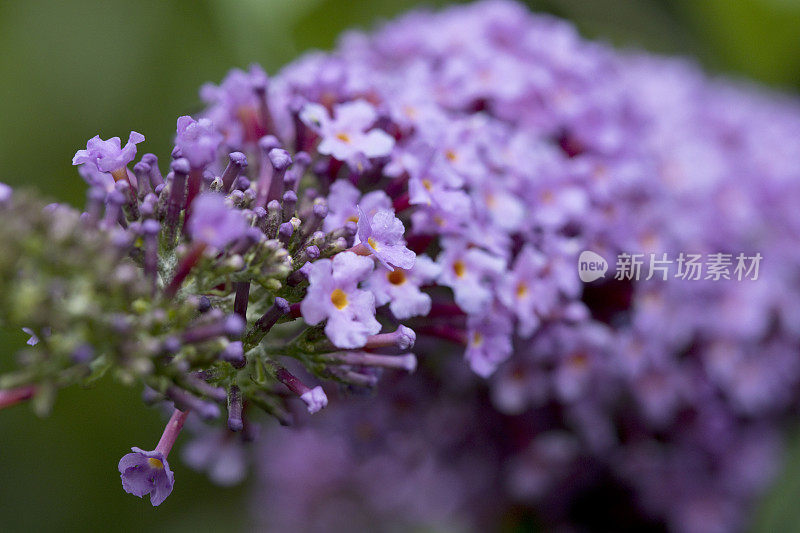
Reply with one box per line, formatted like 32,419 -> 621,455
119,447 -> 175,506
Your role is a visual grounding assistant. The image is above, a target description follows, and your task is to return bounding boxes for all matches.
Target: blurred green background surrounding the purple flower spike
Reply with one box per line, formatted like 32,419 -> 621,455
0,0 -> 800,531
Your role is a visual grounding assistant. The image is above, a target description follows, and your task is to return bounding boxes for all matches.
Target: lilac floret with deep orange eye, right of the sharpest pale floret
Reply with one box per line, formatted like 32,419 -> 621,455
365,255 -> 440,320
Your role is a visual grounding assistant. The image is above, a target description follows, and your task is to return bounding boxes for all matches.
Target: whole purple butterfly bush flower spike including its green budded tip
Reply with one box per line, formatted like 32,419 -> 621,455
0,1 -> 800,532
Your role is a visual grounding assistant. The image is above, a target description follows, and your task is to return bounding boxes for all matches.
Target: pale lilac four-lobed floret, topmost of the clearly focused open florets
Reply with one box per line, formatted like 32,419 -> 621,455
300,100 -> 394,168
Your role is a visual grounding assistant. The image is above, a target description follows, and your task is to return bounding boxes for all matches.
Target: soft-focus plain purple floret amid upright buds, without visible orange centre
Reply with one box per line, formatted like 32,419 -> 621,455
189,192 -> 250,249
